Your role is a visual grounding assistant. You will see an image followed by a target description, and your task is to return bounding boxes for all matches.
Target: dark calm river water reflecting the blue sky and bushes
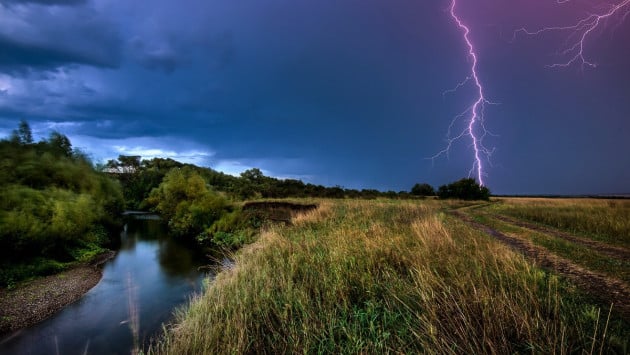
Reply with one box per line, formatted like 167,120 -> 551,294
0,220 -> 208,354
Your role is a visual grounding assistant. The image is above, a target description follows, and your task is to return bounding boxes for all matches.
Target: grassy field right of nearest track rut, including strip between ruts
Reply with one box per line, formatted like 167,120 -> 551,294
462,198 -> 630,284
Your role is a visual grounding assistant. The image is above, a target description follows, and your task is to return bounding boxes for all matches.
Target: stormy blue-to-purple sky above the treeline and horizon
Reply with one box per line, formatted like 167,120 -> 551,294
0,0 -> 630,194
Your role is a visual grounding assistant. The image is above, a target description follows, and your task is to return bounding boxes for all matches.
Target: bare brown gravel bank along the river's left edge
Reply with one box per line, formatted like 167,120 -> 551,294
0,250 -> 116,336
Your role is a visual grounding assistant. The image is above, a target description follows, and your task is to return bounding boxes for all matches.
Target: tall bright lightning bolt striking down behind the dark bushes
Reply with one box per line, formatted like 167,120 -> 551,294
431,0 -> 496,186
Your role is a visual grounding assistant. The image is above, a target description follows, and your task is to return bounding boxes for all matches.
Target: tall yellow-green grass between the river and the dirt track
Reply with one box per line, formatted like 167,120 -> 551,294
149,200 -> 630,354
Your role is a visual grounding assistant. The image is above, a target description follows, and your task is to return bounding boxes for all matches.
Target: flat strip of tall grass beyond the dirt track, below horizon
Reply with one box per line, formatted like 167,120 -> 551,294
494,198 -> 630,247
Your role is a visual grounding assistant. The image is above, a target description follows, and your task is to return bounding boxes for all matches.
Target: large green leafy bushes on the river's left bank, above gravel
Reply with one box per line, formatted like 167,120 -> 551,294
0,121 -> 123,285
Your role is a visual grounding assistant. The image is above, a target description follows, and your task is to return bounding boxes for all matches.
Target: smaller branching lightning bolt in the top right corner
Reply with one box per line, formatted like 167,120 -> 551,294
513,0 -> 630,68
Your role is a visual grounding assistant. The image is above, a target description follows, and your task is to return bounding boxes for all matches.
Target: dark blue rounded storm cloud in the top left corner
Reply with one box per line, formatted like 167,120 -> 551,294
0,1 -> 122,74
